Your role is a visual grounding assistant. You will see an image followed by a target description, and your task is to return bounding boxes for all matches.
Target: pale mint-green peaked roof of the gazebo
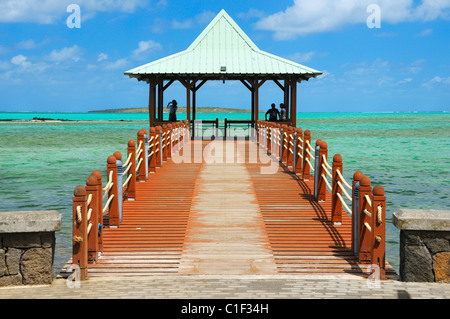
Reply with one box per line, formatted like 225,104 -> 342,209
125,10 -> 322,82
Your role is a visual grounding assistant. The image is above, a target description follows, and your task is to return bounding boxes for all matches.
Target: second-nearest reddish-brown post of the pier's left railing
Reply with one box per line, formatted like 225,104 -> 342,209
86,174 -> 101,263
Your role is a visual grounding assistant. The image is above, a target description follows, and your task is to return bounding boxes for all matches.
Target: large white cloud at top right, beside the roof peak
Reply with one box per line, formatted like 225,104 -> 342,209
256,0 -> 450,40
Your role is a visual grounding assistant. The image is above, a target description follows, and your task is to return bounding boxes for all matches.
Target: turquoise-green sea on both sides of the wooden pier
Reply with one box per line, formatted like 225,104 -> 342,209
0,112 -> 450,272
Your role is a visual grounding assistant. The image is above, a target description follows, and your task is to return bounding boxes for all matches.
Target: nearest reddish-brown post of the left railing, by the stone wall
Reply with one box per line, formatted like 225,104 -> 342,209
72,186 -> 88,280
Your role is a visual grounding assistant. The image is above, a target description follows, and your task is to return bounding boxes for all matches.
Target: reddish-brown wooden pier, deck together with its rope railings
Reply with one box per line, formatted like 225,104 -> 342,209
61,122 -> 395,279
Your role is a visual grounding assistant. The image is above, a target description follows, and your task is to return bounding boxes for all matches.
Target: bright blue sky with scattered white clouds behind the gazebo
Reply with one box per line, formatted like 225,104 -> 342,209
0,0 -> 450,112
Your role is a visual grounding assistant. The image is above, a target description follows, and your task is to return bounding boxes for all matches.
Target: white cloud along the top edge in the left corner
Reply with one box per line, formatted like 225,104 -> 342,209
0,0 -> 148,24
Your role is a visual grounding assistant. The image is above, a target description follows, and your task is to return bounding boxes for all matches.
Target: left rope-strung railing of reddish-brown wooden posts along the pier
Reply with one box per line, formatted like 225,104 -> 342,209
72,121 -> 190,280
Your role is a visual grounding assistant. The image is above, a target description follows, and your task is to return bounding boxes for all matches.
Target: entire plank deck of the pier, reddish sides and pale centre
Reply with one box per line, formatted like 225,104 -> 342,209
63,141 -> 395,277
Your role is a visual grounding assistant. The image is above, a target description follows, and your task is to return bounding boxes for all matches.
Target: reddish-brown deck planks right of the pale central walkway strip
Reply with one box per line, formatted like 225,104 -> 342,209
247,141 -> 394,275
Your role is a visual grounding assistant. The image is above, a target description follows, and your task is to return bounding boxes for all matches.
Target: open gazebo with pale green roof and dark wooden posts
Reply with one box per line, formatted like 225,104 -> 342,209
125,10 -> 322,126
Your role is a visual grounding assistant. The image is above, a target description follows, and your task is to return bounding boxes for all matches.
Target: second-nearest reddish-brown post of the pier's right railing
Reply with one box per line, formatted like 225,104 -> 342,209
358,176 -> 372,263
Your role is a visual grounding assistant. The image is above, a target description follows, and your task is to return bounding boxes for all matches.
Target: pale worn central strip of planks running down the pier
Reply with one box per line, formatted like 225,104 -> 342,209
180,141 -> 277,275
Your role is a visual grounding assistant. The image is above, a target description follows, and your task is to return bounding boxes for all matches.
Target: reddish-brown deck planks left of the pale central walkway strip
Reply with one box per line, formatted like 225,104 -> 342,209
85,149 -> 201,277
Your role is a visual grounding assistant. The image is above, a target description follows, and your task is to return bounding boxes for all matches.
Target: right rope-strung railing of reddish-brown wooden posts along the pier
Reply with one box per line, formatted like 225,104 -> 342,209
256,121 -> 386,279
